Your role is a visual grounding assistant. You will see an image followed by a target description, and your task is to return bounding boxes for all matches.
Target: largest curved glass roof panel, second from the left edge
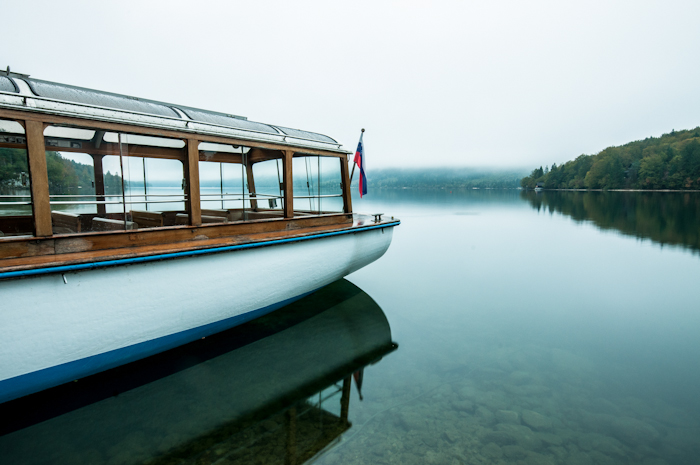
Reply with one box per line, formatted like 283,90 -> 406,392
26,79 -> 180,118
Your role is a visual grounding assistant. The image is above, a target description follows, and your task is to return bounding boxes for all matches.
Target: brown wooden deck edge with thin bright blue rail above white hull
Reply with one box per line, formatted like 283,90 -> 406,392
0,214 -> 399,279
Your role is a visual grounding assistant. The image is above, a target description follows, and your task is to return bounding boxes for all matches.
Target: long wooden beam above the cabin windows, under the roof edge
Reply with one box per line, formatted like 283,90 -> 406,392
0,108 -> 347,157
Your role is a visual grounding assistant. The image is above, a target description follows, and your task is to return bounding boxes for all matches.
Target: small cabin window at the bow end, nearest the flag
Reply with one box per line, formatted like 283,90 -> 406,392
292,155 -> 343,216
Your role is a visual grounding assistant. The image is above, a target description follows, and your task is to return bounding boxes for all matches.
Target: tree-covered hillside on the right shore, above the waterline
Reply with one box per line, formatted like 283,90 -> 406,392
520,127 -> 700,189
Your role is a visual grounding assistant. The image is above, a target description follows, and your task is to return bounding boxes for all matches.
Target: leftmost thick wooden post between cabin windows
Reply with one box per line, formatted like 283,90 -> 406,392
25,120 -> 53,236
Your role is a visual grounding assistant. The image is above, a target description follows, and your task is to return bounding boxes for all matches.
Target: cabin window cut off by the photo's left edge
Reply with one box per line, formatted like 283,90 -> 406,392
0,120 -> 34,240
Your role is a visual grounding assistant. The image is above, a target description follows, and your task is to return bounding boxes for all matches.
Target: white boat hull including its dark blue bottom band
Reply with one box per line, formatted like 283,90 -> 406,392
0,226 -> 393,402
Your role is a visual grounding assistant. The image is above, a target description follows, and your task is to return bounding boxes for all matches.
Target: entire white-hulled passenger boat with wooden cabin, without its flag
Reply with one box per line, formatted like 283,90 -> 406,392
0,68 -> 400,403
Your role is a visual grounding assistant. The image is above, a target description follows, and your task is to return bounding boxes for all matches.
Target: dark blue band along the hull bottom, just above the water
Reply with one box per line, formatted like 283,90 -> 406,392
0,290 -> 316,403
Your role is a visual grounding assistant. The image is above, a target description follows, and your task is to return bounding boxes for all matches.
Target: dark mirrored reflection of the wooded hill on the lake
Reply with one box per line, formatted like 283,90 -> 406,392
521,191 -> 700,251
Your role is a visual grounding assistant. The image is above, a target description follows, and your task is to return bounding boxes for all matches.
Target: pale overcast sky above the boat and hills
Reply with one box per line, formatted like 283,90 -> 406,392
0,0 -> 700,168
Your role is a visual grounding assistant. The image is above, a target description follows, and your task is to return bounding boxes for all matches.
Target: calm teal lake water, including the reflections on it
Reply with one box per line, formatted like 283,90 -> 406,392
0,190 -> 700,465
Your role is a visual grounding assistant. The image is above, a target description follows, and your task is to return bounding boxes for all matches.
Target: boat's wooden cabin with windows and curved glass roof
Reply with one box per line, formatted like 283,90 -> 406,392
0,70 -> 382,272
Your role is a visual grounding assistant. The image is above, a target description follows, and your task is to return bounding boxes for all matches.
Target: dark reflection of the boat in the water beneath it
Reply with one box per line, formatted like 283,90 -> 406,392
0,280 -> 397,464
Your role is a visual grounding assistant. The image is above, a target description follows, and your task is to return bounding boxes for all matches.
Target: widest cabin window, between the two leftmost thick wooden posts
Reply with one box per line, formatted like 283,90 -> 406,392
44,126 -> 188,234
